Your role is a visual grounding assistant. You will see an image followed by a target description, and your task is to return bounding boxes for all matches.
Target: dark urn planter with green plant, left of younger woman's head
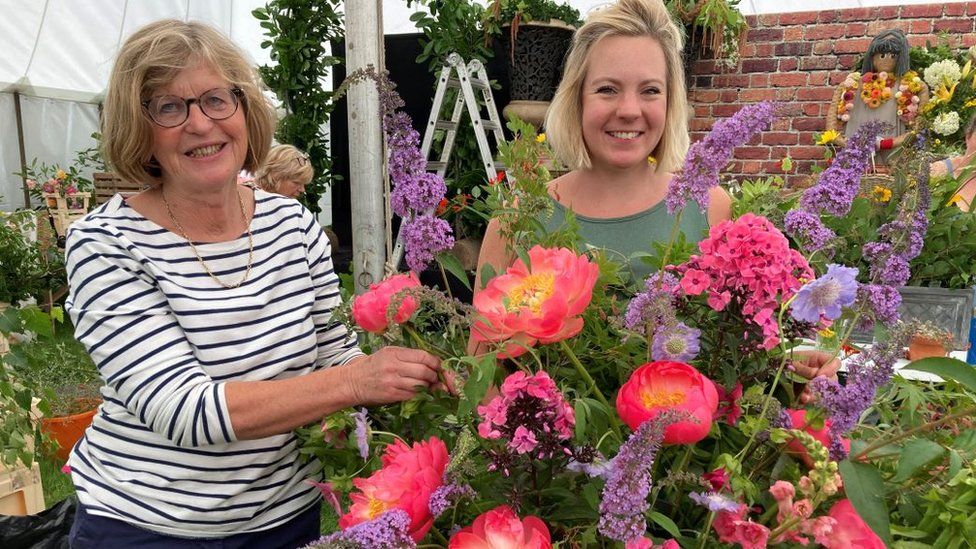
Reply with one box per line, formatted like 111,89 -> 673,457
483,0 -> 582,128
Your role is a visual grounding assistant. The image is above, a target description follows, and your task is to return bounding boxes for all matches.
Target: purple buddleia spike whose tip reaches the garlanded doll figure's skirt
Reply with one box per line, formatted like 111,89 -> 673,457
784,120 -> 887,252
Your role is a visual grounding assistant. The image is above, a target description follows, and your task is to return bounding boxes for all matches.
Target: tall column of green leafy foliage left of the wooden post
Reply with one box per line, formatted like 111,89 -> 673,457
252,0 -> 343,212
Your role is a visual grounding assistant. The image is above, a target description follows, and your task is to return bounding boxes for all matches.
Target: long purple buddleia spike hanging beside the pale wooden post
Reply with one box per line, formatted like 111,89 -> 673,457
366,69 -> 454,271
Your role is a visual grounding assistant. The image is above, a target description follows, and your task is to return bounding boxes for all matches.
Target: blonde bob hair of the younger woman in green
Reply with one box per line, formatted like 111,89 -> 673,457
545,0 -> 688,172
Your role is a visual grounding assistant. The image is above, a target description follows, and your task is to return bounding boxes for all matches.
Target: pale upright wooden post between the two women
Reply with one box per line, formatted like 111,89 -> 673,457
346,0 -> 386,293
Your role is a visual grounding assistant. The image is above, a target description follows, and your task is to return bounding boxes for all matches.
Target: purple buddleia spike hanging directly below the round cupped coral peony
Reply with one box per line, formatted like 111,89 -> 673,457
597,412 -> 675,543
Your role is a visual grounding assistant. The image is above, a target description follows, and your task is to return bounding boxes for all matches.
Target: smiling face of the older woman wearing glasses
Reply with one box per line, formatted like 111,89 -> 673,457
151,60 -> 247,190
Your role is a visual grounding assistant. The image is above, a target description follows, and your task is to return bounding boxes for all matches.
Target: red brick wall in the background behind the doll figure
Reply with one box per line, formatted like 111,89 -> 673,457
690,2 -> 976,185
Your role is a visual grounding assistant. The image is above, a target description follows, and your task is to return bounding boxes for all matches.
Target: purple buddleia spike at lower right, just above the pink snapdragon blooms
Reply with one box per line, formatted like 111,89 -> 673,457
810,329 -> 908,461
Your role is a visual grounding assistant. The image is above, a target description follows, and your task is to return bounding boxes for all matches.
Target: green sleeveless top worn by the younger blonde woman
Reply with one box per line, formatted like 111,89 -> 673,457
542,197 -> 708,284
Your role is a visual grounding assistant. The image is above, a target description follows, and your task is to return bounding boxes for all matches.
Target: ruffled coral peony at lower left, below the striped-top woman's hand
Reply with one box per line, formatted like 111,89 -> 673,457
339,437 -> 448,542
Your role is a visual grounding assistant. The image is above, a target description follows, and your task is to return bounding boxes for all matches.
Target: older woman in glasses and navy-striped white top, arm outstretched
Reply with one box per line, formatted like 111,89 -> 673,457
66,21 -> 440,548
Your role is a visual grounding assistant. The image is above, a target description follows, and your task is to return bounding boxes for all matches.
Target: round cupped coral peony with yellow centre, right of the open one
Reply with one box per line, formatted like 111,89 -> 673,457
617,361 -> 718,444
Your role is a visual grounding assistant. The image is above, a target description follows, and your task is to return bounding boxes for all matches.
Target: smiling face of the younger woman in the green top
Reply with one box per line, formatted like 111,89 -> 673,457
582,36 -> 668,169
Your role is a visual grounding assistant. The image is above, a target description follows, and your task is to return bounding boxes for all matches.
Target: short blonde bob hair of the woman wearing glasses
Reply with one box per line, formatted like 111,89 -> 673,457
102,19 -> 277,185
